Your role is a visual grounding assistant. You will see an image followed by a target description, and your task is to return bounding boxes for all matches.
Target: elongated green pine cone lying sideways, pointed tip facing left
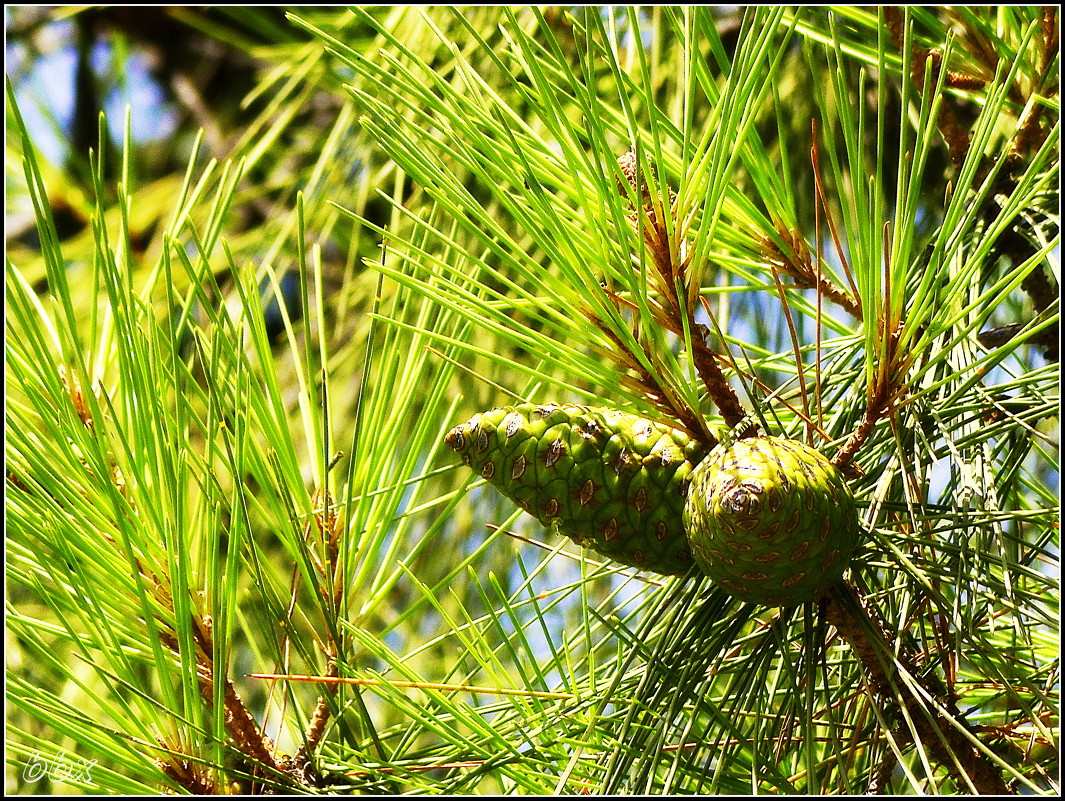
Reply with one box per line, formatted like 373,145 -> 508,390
444,404 -> 704,575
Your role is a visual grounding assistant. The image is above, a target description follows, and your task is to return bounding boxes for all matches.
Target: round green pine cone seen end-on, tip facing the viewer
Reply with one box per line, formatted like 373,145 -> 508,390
684,437 -> 859,606
